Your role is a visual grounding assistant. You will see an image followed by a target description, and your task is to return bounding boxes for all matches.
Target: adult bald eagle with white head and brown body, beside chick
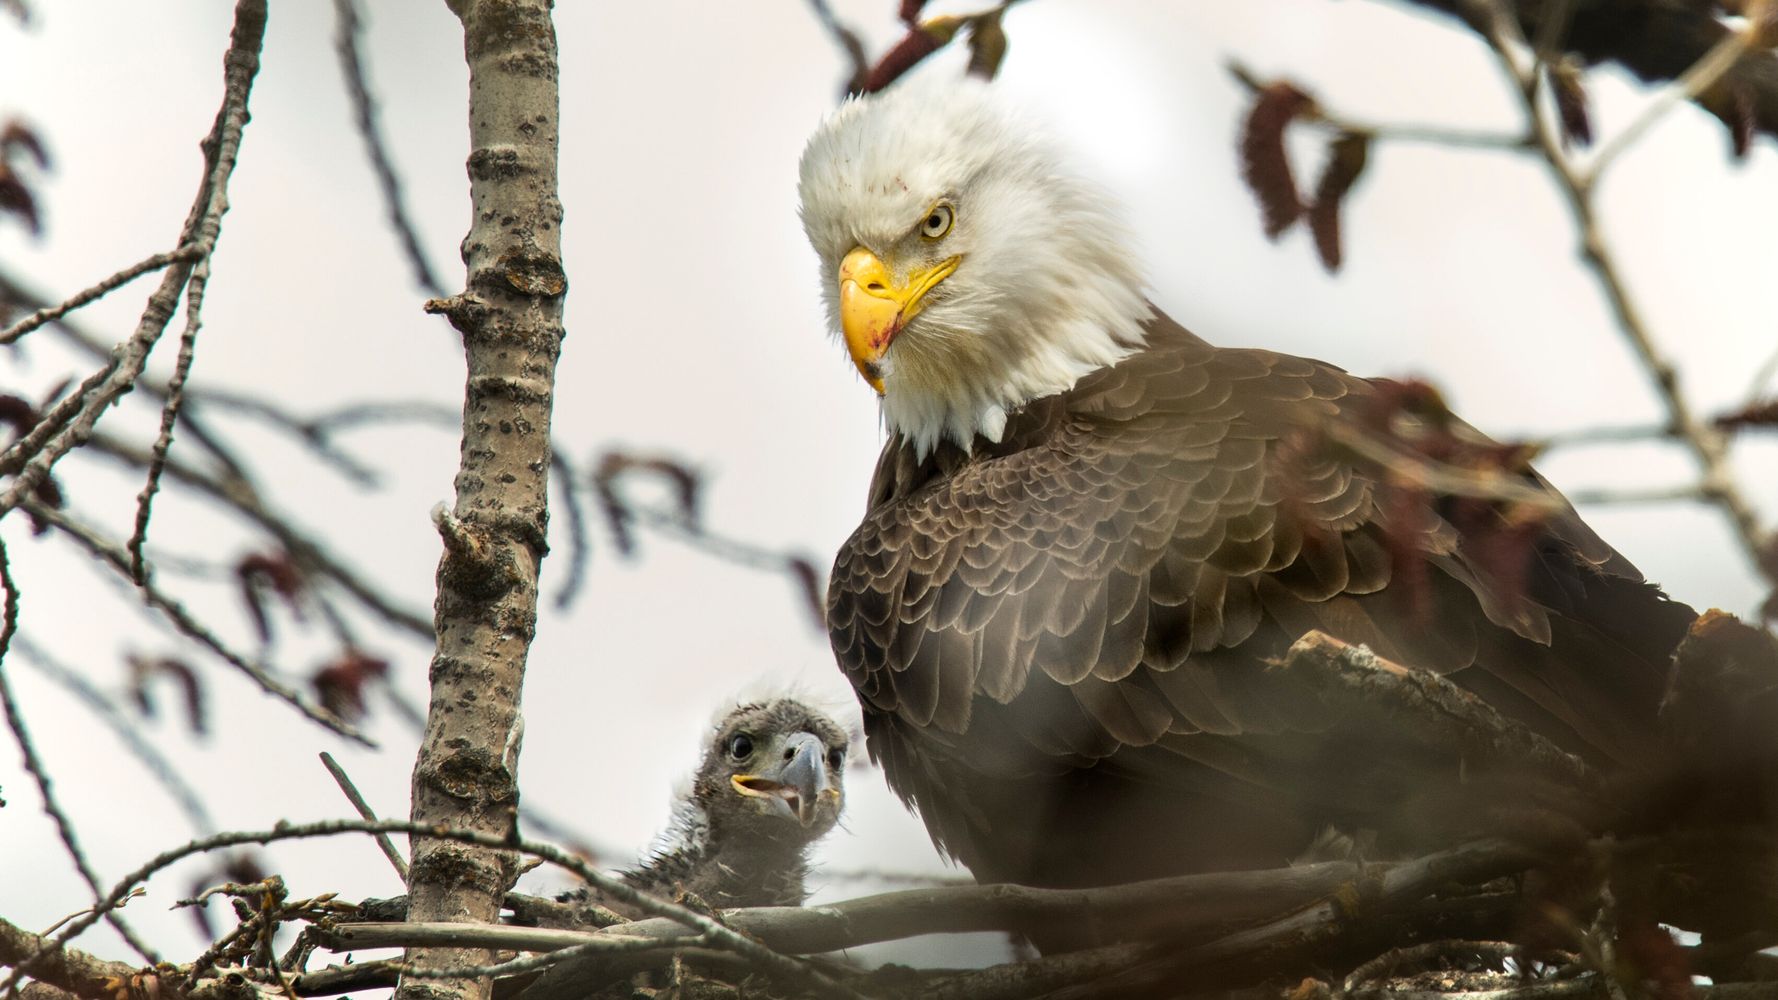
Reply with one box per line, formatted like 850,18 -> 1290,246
800,80 -> 1694,886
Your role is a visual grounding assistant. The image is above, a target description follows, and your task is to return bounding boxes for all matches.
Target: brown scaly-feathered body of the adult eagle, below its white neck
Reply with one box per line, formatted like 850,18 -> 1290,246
829,317 -> 1693,884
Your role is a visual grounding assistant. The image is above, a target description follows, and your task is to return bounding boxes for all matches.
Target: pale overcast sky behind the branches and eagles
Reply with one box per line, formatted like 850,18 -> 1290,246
0,0 -> 1778,963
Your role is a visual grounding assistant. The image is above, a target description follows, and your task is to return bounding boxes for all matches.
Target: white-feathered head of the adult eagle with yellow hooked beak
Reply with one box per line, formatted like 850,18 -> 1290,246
800,78 -> 1150,456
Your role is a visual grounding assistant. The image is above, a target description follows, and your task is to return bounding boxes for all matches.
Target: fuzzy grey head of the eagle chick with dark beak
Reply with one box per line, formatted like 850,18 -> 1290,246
692,698 -> 850,845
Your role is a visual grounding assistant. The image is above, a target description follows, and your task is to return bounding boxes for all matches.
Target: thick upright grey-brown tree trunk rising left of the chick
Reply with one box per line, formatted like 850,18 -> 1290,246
396,0 -> 565,1000
